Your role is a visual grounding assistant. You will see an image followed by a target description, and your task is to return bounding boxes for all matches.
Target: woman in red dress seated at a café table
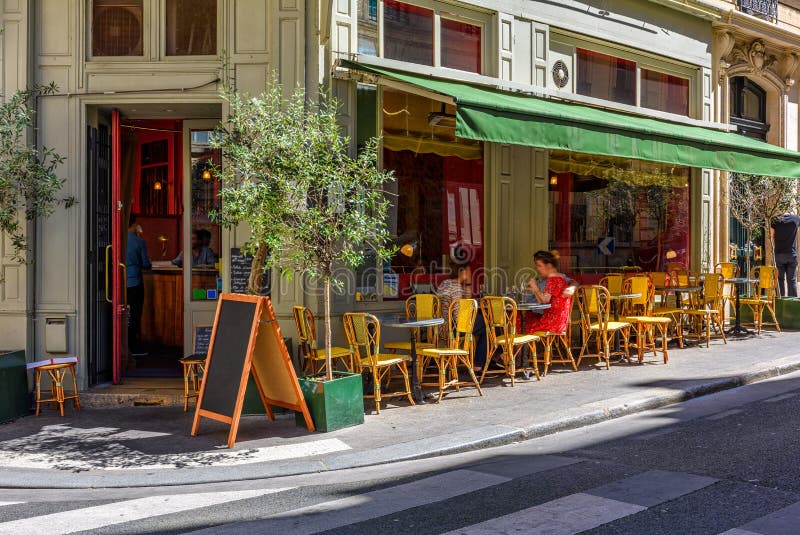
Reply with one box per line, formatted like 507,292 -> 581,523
525,251 -> 572,334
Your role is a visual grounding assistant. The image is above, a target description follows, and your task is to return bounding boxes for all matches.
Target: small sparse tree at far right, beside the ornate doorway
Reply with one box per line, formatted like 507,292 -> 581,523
727,174 -> 798,273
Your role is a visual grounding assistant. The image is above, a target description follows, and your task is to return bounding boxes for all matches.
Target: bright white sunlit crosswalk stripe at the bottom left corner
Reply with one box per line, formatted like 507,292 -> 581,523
0,488 -> 291,535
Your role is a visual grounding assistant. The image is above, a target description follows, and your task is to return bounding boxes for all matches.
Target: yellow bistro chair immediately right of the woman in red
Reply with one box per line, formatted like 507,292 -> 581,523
576,286 -> 631,369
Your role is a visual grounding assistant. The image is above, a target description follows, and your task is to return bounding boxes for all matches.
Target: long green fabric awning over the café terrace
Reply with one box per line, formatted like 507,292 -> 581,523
342,61 -> 800,177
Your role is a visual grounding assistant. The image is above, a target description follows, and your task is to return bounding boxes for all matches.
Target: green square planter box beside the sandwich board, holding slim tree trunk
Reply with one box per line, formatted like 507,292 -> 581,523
295,371 -> 364,432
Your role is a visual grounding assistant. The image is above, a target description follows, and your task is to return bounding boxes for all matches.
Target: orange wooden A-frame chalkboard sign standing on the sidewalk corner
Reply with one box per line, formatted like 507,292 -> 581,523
192,293 -> 314,448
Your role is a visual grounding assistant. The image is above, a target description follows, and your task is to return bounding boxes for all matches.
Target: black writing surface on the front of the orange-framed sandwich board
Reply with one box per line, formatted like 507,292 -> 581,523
198,299 -> 257,418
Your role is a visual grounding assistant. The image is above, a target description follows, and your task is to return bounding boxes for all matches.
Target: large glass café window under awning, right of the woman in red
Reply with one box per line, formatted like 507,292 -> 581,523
549,151 -> 690,284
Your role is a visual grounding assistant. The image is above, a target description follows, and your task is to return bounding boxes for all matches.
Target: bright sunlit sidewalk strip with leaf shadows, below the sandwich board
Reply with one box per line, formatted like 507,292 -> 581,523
0,424 -> 351,470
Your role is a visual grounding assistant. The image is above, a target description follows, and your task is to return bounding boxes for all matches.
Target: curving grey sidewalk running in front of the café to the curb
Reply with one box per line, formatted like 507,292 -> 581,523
0,332 -> 800,488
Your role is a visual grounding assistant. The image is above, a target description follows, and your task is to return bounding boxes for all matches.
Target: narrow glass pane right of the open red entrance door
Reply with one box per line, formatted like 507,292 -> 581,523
188,131 -> 222,300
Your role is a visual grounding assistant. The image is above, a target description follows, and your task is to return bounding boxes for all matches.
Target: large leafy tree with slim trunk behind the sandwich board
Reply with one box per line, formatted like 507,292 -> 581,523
214,81 -> 392,380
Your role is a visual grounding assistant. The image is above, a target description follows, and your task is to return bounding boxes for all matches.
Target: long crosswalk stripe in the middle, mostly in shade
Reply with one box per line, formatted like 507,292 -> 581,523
191,470 -> 511,535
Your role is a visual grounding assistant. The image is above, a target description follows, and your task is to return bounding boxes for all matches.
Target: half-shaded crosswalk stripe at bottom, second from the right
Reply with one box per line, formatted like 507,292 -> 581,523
440,493 -> 647,535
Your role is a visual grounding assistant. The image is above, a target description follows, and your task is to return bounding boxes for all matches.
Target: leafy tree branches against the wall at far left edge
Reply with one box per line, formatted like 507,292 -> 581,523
0,84 -> 67,262
